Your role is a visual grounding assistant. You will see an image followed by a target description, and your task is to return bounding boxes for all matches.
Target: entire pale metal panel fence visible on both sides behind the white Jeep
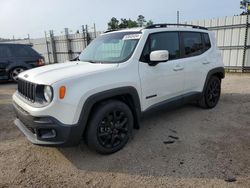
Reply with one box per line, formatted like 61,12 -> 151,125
1,15 -> 250,72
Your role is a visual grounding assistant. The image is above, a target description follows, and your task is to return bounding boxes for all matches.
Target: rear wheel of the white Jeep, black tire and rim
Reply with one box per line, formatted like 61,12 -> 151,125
198,76 -> 221,109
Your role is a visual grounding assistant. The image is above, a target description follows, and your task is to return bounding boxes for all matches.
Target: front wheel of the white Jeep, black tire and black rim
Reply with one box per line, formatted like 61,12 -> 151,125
85,100 -> 134,154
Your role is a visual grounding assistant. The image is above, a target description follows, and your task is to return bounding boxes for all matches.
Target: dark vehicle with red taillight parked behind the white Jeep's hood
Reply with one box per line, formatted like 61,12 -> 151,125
0,43 -> 45,81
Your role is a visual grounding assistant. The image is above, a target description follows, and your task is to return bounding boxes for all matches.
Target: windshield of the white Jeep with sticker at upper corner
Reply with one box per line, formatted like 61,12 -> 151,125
79,32 -> 141,63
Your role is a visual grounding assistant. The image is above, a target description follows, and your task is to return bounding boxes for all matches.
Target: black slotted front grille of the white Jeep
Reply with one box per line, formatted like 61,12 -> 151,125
17,79 -> 36,102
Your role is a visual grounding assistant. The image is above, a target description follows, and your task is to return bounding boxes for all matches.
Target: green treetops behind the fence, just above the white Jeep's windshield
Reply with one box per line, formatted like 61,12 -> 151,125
108,15 -> 153,30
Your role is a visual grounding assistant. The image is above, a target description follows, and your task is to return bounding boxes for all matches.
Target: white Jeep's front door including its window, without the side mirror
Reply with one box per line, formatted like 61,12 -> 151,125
139,32 -> 185,109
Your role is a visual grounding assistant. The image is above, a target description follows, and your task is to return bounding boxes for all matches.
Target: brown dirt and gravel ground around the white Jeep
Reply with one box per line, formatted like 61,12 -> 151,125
0,74 -> 250,187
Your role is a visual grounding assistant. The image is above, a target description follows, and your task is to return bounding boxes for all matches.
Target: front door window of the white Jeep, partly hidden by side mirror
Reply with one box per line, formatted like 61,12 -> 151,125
141,32 -> 180,62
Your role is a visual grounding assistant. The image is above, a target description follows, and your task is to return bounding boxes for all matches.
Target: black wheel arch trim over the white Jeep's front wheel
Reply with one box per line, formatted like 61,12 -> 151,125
78,86 -> 141,137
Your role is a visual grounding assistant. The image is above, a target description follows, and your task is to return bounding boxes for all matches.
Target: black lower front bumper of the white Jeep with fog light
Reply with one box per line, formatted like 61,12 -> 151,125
13,103 -> 83,146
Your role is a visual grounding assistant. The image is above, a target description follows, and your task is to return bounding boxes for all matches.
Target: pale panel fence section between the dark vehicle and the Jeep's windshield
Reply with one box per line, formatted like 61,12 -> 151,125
0,28 -> 102,64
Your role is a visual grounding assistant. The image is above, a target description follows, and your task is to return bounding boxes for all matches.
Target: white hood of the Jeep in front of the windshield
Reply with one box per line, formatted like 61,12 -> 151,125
18,61 -> 118,85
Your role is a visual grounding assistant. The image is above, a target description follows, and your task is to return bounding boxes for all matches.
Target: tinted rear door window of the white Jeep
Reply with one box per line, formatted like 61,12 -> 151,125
181,32 -> 204,57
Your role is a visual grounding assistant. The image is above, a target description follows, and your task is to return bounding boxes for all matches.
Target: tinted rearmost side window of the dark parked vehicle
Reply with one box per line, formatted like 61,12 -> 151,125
11,45 -> 38,57
